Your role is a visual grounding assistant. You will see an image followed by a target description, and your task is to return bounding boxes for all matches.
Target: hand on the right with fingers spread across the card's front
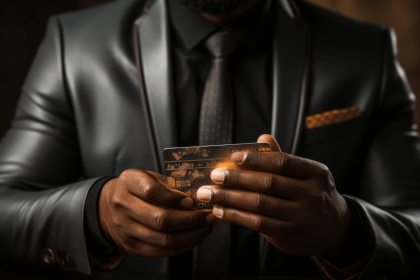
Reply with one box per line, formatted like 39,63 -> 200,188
197,135 -> 351,257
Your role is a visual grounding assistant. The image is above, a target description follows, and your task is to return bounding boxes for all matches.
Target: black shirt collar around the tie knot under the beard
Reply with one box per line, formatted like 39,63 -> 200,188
168,0 -> 272,52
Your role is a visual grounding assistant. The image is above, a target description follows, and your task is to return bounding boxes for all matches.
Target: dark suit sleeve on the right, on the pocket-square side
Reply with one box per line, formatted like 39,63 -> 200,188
347,27 -> 420,279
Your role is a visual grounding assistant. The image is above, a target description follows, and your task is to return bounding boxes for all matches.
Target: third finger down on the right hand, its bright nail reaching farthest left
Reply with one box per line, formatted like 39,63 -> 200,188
197,186 -> 299,220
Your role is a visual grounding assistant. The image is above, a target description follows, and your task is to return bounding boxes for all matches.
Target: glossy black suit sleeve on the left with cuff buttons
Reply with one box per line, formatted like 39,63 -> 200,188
0,17 -> 99,274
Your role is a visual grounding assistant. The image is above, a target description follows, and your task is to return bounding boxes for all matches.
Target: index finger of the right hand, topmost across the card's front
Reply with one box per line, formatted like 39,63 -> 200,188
232,152 -> 322,178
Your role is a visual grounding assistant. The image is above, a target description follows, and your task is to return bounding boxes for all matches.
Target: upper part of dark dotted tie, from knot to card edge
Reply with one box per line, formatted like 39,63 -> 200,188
199,32 -> 237,146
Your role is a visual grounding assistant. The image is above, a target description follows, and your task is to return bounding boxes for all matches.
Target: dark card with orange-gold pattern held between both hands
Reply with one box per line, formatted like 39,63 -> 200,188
163,143 -> 271,209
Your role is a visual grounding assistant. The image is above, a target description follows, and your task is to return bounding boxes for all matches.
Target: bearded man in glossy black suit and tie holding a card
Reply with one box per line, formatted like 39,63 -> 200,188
0,0 -> 420,279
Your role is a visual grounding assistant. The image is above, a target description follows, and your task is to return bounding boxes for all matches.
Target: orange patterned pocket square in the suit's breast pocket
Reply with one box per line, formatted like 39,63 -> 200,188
305,107 -> 360,128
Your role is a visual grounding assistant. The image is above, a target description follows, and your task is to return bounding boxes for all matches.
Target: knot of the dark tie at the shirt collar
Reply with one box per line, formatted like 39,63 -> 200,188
206,32 -> 238,58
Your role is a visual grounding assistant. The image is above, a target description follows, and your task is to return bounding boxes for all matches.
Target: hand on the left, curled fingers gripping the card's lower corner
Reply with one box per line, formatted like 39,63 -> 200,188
99,169 -> 220,257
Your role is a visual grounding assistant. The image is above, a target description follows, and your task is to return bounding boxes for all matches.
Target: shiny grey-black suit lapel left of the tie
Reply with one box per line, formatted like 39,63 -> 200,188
134,0 -> 176,173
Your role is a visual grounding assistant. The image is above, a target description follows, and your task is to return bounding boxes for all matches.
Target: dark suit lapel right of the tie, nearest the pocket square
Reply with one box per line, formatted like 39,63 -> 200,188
271,0 -> 311,154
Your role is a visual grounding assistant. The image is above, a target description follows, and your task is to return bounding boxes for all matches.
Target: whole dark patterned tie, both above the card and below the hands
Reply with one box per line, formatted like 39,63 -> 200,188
194,32 -> 237,279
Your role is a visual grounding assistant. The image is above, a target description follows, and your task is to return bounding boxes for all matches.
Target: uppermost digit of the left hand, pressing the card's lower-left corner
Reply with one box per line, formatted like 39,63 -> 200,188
120,169 -> 194,209
